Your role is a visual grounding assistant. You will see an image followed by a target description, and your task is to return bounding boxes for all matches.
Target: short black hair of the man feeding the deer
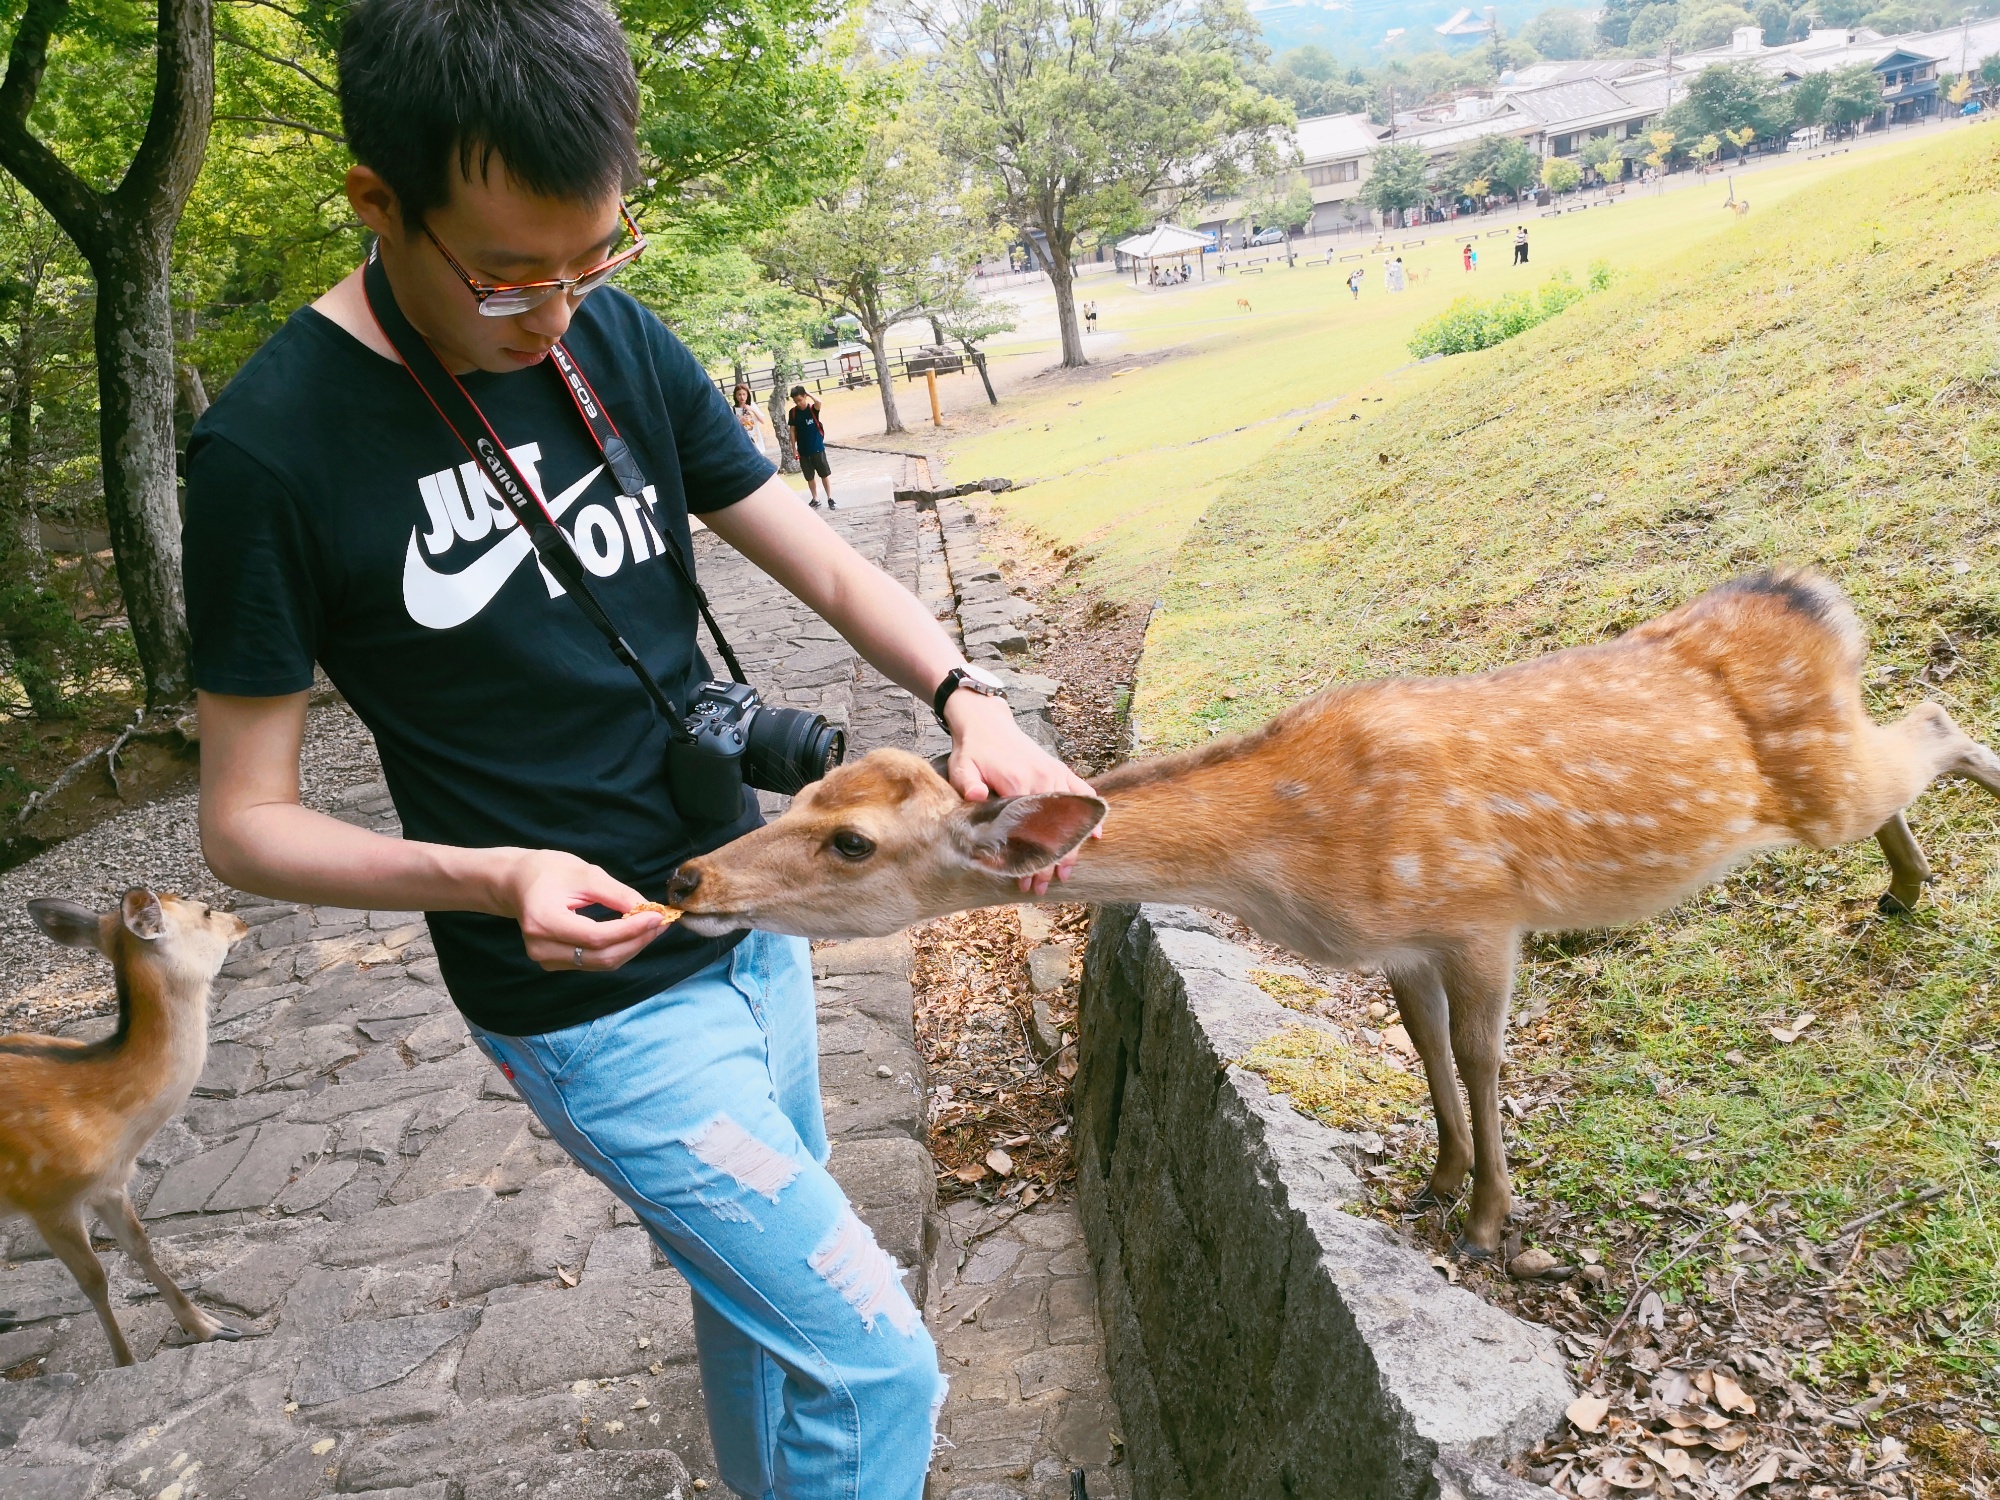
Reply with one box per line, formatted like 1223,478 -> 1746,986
340,0 -> 638,228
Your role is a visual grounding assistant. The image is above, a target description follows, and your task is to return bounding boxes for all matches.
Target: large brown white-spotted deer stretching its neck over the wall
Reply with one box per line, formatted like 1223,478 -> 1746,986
670,574 -> 2000,1254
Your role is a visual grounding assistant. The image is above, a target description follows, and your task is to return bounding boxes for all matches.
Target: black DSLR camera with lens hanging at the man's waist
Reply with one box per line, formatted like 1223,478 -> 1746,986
666,682 -> 848,828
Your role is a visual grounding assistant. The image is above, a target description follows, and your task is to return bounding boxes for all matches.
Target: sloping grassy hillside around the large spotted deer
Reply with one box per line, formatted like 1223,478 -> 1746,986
1136,128 -> 2000,1472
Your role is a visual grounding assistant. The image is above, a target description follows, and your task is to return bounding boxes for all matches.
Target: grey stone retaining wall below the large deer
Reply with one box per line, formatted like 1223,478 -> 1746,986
1076,906 -> 1572,1500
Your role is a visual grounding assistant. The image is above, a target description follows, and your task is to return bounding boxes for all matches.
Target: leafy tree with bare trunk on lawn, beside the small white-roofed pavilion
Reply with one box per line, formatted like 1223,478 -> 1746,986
900,0 -> 1292,366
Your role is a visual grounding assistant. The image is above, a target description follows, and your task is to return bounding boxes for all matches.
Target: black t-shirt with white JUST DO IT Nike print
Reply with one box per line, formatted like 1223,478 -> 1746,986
186,288 -> 772,1036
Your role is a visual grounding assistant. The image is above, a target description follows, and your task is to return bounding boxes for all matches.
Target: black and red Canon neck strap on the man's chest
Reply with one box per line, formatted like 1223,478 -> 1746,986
362,246 -> 744,724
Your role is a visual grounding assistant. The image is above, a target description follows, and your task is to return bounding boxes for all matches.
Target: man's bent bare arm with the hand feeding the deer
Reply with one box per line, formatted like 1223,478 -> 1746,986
200,692 -> 660,970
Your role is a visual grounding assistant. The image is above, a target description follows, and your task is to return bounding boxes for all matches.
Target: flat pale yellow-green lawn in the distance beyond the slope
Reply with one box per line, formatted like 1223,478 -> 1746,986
950,132 -> 1968,598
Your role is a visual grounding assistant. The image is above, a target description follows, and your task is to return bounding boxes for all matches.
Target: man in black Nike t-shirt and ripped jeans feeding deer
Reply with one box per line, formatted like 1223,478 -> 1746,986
186,0 -> 1082,1500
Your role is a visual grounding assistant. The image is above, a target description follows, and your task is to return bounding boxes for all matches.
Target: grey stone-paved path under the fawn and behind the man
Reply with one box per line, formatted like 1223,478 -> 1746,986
0,482 -> 1120,1500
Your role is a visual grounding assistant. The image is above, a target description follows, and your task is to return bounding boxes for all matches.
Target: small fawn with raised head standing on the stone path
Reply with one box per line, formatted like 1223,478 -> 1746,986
0,890 -> 250,1364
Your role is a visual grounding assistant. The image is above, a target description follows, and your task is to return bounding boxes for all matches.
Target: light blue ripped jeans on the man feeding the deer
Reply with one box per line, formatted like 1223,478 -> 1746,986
472,932 -> 944,1500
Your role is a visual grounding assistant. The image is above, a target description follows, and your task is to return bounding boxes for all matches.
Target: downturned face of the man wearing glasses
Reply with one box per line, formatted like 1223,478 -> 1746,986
348,156 -> 620,374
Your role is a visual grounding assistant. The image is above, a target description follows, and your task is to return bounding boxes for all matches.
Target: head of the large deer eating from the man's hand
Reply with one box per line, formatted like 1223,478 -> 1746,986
668,750 -> 1104,938
